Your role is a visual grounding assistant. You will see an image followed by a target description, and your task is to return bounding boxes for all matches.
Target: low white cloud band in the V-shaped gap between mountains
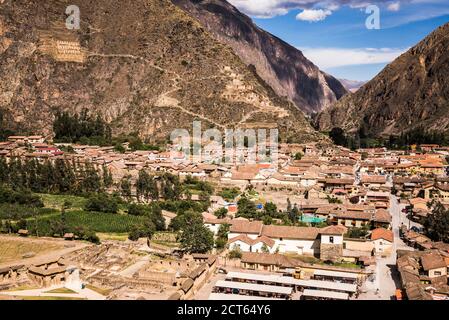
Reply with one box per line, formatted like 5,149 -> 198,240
298,48 -> 407,69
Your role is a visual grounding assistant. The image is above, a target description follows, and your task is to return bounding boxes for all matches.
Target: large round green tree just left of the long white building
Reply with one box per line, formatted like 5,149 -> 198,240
180,221 -> 214,253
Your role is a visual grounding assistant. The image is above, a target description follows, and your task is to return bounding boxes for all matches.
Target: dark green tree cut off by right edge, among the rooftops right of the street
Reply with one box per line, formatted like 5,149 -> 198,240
424,202 -> 449,243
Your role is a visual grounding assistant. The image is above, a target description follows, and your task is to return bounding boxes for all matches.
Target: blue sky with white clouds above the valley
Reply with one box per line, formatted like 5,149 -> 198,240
228,0 -> 449,80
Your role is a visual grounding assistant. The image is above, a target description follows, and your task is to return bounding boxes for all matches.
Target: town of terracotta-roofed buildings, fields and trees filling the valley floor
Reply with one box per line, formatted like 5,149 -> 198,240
0,135 -> 449,300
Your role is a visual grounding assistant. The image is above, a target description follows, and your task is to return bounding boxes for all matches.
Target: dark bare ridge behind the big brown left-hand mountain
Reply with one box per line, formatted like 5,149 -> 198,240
172,0 -> 347,113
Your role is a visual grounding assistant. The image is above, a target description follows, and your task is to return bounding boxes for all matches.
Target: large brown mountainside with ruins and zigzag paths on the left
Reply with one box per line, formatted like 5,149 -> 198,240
0,0 -> 323,142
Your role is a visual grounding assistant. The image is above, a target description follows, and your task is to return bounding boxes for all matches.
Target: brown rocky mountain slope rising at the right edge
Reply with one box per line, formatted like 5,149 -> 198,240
317,23 -> 449,136
